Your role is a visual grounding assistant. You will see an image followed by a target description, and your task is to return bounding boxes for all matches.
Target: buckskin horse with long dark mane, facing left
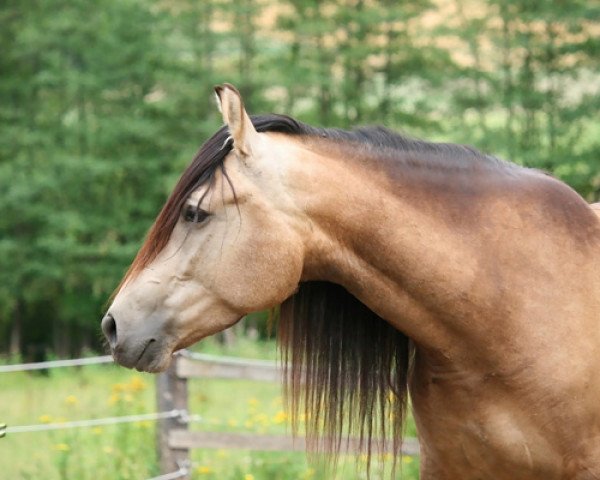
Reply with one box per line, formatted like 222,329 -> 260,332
101,84 -> 600,480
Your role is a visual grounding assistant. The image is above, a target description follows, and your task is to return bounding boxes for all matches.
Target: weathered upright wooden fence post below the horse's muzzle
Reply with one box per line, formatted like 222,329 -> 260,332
156,356 -> 189,473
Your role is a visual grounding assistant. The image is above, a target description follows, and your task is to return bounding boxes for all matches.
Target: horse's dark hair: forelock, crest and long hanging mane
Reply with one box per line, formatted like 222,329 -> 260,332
117,111 -> 508,472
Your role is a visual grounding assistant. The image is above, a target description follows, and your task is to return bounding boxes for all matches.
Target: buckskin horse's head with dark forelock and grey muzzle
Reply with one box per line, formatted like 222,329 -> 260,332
102,85 -> 306,372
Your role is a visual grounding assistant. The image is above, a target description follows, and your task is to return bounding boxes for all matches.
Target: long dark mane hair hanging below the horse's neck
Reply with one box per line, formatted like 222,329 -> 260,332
278,281 -> 413,473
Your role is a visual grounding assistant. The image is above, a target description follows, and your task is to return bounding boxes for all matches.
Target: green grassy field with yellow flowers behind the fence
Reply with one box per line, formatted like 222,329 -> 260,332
0,341 -> 418,480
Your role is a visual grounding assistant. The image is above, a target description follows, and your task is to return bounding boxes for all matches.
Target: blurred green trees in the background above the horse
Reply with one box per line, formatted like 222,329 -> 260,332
0,0 -> 600,357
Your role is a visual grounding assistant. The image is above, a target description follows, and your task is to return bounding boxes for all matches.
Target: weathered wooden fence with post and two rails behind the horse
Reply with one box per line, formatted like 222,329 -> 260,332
156,353 -> 419,473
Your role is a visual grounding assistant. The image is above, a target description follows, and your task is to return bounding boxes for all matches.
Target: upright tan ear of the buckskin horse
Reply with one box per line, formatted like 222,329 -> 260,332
215,83 -> 257,155
